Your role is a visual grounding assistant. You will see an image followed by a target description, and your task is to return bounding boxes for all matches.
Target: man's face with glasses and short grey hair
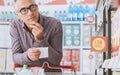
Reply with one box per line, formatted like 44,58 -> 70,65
16,0 -> 39,25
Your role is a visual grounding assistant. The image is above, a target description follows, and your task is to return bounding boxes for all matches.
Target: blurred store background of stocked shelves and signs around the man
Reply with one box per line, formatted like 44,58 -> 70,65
0,0 -> 120,75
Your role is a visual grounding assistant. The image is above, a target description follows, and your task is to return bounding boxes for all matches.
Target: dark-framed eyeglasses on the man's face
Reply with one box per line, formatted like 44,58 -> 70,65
18,4 -> 37,15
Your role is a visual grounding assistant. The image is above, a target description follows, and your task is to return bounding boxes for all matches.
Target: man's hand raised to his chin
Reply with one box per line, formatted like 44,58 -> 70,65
30,22 -> 44,41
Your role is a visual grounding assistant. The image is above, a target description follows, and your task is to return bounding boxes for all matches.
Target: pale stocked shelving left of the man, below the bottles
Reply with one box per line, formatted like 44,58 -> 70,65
0,22 -> 14,75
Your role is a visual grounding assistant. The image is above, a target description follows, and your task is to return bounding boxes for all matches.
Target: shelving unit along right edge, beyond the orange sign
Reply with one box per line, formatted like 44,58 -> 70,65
95,0 -> 120,75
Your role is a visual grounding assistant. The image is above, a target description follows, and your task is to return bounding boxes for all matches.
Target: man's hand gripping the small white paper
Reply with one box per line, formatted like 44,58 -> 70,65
28,48 -> 41,61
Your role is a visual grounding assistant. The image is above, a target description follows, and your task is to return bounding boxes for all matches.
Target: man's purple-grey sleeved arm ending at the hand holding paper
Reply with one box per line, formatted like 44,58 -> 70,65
10,23 -> 30,65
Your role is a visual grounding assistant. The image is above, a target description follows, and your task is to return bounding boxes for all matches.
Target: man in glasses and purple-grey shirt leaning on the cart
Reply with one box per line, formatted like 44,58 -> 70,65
10,0 -> 62,71
